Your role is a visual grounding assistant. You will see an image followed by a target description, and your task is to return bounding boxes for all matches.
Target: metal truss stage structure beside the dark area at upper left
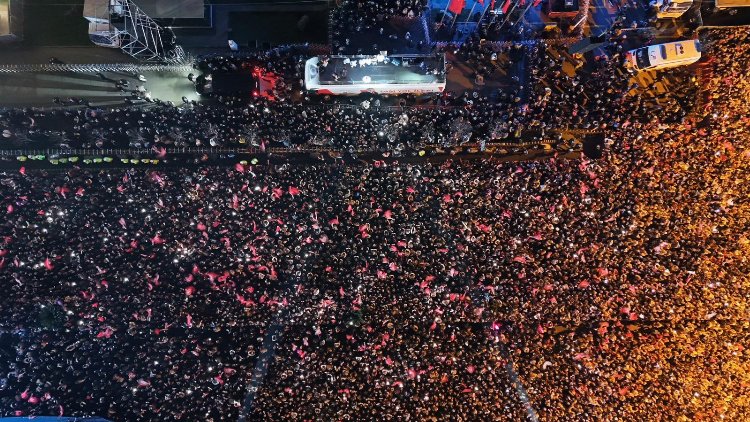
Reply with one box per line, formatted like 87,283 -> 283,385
83,0 -> 185,63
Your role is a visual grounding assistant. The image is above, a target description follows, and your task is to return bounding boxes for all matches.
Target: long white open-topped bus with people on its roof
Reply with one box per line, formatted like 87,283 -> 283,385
305,54 -> 446,95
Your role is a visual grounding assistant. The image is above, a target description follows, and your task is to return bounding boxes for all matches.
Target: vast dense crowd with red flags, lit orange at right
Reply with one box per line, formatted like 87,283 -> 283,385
0,20 -> 750,421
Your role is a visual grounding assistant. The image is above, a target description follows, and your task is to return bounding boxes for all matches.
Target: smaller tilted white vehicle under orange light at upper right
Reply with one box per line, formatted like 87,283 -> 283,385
625,40 -> 701,71
